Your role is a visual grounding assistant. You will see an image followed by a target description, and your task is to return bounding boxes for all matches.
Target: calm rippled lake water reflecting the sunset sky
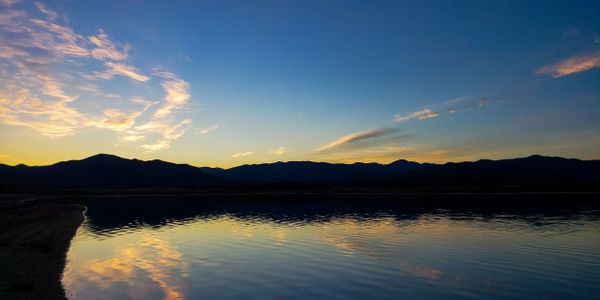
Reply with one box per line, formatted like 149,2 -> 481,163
63,196 -> 600,299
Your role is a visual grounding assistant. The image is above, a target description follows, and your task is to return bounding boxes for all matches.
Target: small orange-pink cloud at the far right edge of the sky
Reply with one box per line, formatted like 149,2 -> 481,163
536,52 -> 600,78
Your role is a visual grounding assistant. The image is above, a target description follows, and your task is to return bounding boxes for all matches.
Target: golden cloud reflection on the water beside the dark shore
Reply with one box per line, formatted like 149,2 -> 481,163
63,233 -> 189,299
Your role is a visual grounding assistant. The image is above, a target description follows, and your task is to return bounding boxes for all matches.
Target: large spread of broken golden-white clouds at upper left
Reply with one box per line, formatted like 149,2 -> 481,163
0,0 -> 193,151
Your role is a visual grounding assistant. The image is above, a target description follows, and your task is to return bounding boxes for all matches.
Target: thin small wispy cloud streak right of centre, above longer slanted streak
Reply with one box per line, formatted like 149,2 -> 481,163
394,98 -> 496,123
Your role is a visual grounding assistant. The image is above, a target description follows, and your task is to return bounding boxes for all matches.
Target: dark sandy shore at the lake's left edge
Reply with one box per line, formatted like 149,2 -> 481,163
0,198 -> 84,299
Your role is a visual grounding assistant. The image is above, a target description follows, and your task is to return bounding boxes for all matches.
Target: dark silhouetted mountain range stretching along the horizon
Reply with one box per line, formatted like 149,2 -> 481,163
0,154 -> 600,188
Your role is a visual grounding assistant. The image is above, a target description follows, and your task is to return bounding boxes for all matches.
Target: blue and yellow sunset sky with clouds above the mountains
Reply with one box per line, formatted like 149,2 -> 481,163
0,0 -> 600,167
